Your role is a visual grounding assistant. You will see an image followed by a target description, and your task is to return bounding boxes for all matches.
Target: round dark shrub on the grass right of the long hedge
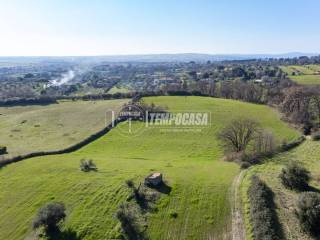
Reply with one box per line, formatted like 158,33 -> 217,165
279,163 -> 310,191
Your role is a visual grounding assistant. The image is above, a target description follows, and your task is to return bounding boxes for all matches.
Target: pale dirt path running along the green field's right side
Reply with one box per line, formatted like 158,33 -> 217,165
231,170 -> 246,240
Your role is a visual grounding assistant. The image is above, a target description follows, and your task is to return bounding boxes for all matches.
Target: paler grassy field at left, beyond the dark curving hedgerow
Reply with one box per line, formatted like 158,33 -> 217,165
0,100 -> 127,157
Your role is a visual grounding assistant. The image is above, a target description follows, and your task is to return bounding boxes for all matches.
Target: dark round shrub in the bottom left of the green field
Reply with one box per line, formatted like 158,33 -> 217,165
33,203 -> 66,232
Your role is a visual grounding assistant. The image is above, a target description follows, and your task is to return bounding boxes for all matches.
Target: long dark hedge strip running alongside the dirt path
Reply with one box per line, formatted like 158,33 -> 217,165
248,176 -> 283,240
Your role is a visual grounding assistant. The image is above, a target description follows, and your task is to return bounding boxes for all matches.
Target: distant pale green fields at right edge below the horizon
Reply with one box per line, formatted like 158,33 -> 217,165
281,65 -> 320,85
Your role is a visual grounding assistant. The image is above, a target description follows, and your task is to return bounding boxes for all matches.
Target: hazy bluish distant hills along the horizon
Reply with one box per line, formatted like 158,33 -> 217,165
0,52 -> 319,63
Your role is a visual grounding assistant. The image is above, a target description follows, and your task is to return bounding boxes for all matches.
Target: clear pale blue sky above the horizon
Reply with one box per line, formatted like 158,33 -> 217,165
0,0 -> 320,56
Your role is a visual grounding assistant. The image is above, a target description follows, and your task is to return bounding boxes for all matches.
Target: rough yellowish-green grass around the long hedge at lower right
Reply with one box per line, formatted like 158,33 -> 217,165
241,140 -> 320,240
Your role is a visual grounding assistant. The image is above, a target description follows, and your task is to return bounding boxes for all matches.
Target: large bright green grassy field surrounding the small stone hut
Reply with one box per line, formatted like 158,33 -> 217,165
0,97 -> 299,240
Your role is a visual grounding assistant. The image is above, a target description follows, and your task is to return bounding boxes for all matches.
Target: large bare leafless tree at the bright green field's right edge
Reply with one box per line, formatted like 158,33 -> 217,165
218,119 -> 259,152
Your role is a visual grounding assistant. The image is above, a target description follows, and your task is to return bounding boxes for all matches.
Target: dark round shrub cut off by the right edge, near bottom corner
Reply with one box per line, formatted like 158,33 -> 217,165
296,192 -> 320,236
